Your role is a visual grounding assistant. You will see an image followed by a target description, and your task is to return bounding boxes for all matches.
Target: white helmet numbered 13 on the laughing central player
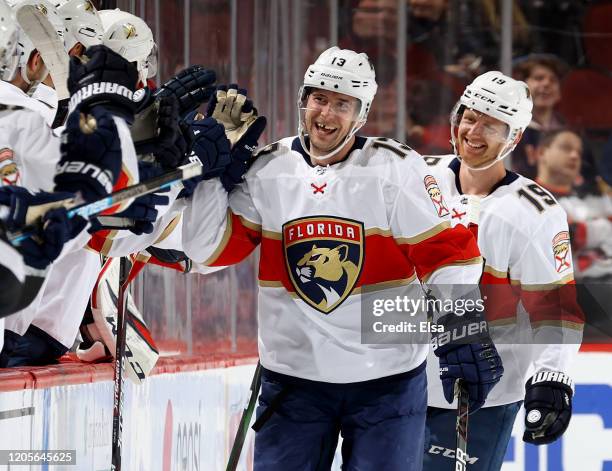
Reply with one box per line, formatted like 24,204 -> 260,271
298,46 -> 378,160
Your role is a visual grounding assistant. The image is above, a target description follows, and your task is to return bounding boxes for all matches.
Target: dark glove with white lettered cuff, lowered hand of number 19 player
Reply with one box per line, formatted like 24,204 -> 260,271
523,371 -> 573,445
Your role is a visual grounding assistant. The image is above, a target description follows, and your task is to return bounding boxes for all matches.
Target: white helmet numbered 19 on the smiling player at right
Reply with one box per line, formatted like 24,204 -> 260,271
450,70 -> 533,170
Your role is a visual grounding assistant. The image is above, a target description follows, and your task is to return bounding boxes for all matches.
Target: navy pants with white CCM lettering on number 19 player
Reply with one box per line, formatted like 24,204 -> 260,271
423,401 -> 522,471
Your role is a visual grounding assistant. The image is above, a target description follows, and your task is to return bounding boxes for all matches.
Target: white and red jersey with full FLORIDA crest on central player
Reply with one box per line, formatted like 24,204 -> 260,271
183,137 -> 482,383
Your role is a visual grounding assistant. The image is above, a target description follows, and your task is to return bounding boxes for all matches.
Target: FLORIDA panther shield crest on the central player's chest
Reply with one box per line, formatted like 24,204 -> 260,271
283,216 -> 365,314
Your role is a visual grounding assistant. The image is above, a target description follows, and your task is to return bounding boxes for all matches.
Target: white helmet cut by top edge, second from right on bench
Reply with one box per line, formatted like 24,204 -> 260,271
55,0 -> 104,50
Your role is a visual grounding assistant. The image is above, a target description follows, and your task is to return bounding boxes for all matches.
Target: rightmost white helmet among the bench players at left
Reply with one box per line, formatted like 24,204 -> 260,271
98,8 -> 155,83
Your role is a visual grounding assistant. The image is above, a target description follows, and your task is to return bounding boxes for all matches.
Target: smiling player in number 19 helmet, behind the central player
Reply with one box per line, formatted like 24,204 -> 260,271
424,72 -> 583,471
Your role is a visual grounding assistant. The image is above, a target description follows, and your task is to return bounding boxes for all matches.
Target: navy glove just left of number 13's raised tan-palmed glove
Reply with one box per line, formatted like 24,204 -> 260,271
179,112 -> 231,198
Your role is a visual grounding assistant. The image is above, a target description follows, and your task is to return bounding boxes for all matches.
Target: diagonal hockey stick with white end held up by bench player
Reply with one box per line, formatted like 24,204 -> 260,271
7,162 -> 202,246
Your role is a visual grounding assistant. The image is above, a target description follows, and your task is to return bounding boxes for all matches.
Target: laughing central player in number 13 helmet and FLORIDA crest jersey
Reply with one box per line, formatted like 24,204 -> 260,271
178,47 -> 502,471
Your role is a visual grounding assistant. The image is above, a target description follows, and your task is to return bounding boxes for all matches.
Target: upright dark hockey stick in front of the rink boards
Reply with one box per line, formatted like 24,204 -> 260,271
111,257 -> 132,471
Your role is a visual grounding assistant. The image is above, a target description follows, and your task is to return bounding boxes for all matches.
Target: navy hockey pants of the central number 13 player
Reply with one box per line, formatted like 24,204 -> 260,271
254,363 -> 427,471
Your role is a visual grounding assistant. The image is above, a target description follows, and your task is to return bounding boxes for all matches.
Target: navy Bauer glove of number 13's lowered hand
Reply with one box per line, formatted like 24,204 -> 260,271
432,313 -> 504,414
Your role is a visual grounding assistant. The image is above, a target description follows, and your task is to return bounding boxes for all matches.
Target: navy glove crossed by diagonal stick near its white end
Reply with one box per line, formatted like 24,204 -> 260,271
89,162 -> 170,235
